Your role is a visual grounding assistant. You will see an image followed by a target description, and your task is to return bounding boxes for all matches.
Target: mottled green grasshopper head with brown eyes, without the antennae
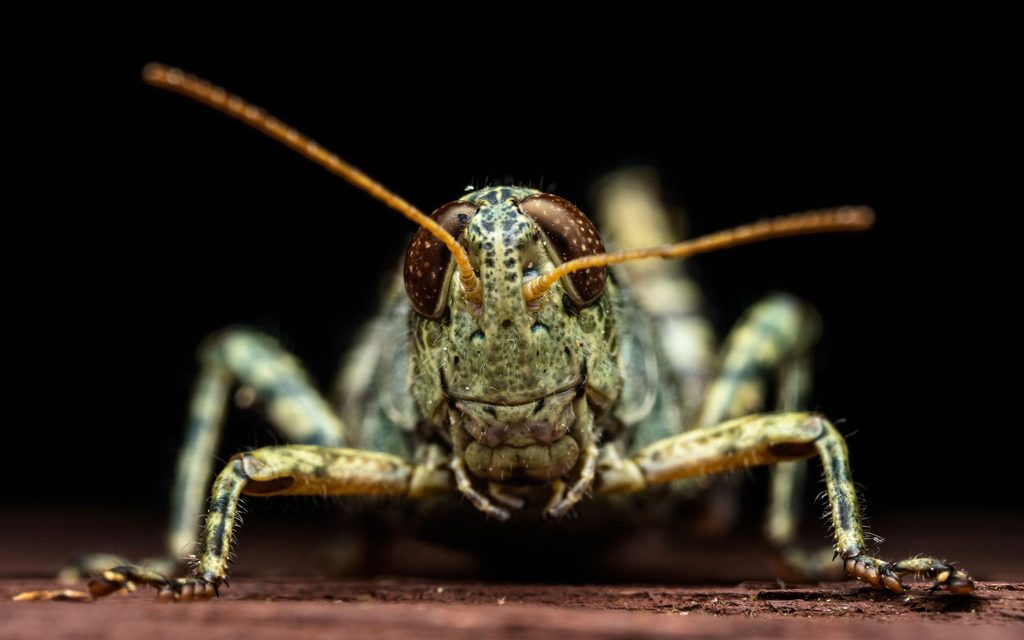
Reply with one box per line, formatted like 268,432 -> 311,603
406,186 -> 621,483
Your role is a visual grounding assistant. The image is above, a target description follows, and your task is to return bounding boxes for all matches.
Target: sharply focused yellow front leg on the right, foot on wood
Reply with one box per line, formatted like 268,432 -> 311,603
599,413 -> 974,594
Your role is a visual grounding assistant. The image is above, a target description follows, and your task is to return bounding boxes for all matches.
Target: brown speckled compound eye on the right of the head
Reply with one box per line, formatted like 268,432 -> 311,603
519,194 -> 608,306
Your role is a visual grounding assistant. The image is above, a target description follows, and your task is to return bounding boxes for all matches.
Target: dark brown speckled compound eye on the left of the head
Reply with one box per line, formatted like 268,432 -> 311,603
404,202 -> 476,317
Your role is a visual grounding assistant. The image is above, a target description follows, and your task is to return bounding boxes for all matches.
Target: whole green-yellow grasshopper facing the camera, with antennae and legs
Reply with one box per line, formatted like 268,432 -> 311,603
44,65 -> 974,601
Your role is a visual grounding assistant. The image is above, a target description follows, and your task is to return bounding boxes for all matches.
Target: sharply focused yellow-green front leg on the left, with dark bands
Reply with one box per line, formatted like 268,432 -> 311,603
89,444 -> 418,601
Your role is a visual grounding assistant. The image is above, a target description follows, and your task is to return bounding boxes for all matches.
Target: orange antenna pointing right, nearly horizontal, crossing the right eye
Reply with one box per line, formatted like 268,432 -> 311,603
522,207 -> 874,302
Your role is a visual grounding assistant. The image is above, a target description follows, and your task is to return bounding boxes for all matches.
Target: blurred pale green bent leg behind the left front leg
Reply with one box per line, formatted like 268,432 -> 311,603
68,328 -> 345,582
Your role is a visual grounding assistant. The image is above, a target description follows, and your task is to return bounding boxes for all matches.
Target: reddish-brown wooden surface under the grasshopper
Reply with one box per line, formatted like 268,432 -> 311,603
0,511 -> 1024,640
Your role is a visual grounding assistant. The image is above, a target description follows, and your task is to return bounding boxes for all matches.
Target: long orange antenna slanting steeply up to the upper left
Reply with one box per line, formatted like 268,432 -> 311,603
142,62 -> 483,302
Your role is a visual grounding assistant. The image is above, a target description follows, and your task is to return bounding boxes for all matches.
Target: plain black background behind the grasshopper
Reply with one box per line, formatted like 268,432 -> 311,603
18,2 -> 1019,520
